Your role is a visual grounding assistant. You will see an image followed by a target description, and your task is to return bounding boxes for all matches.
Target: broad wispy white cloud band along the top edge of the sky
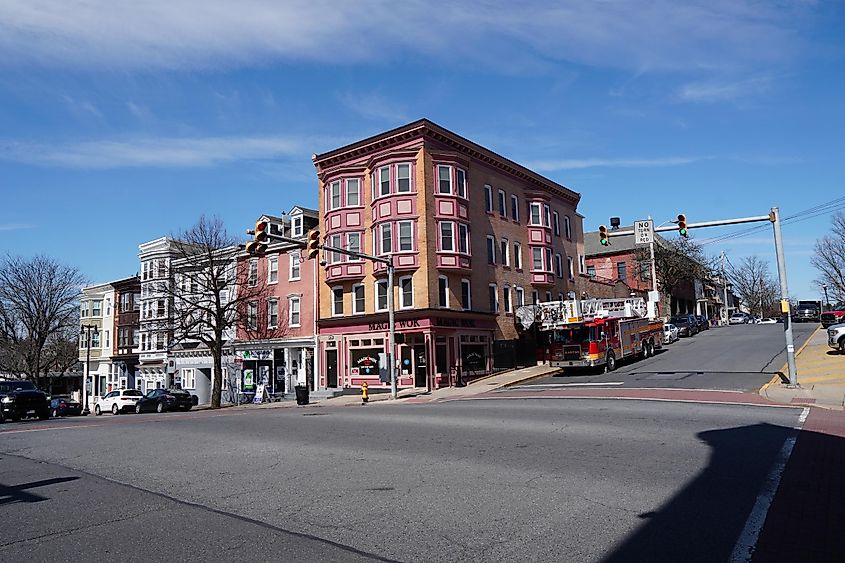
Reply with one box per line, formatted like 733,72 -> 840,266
0,0 -> 817,71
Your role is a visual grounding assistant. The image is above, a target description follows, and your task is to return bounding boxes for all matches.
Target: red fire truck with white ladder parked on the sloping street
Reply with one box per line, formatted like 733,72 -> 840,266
523,298 -> 663,371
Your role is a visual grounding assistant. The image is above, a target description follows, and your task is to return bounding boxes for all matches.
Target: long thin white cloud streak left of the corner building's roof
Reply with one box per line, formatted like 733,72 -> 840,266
0,136 -> 318,169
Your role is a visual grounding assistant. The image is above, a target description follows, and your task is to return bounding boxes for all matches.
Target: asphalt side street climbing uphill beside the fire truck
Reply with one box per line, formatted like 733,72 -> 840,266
511,324 -> 819,391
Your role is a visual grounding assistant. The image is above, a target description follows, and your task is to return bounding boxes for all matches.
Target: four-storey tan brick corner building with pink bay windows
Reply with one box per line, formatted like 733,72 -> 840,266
313,119 -> 584,389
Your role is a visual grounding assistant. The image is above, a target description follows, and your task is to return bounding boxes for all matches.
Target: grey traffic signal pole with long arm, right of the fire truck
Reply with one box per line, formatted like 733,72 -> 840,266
599,207 -> 798,387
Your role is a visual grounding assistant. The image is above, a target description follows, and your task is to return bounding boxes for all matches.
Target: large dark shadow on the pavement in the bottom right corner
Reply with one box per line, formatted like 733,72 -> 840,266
603,424 -> 845,563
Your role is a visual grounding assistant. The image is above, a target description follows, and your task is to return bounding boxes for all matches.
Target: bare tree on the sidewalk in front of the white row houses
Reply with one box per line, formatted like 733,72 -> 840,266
161,215 -> 287,408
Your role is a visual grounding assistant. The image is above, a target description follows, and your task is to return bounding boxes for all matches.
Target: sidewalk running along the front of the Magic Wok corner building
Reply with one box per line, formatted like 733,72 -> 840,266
323,366 -> 560,405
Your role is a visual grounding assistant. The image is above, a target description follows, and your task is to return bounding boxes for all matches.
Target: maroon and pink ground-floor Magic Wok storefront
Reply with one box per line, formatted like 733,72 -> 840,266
319,311 -> 496,390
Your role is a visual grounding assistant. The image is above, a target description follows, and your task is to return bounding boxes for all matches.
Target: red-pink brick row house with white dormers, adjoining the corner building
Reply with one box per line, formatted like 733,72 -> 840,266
234,206 -> 319,394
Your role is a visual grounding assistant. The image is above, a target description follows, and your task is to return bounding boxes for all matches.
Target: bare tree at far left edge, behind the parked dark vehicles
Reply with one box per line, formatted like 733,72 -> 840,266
0,255 -> 85,387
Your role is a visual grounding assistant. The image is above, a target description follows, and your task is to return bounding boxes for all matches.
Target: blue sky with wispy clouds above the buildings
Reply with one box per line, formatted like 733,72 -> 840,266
0,0 -> 845,298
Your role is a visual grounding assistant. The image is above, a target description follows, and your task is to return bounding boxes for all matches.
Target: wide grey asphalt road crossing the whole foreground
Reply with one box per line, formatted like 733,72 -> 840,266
0,398 -> 801,563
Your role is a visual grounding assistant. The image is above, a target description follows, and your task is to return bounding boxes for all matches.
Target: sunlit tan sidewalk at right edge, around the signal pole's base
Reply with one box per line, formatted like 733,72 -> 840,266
760,326 -> 845,410
